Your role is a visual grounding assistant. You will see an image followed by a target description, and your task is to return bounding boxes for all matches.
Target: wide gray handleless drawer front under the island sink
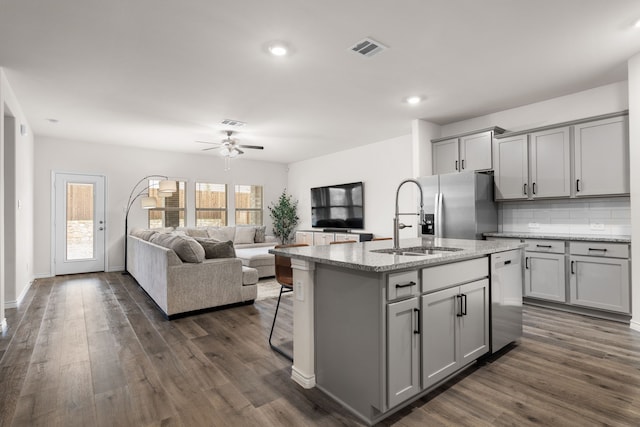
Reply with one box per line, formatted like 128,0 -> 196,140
422,257 -> 489,292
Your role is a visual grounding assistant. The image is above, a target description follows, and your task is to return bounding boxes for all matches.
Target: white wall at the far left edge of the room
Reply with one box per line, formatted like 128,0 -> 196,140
0,69 -> 34,314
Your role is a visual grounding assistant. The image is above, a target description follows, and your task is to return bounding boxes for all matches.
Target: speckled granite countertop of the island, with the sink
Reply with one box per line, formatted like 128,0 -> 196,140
269,238 -> 524,272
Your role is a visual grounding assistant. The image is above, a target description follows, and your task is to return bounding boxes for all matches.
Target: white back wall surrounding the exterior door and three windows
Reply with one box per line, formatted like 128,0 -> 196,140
35,137 -> 287,277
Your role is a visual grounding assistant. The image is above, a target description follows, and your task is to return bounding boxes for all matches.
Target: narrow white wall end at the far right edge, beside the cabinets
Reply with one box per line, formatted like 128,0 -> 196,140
628,53 -> 640,331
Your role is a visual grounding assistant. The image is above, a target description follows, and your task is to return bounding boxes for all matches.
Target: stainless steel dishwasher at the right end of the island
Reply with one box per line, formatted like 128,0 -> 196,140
491,249 -> 524,353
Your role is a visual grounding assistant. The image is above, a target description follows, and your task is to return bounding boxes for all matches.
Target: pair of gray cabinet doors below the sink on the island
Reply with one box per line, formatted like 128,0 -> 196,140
421,279 -> 489,389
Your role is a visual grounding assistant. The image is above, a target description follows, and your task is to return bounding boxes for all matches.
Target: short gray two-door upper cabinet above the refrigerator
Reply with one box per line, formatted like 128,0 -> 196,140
431,127 -> 504,175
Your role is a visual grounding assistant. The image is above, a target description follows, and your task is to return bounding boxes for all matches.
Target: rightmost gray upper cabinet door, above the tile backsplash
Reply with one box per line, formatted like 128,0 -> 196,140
573,117 -> 629,197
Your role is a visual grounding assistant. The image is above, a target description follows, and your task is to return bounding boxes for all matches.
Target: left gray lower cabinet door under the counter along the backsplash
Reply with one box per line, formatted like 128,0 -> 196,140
524,251 -> 567,302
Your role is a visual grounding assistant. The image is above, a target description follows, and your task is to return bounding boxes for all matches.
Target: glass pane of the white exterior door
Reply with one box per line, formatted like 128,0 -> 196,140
66,182 -> 95,260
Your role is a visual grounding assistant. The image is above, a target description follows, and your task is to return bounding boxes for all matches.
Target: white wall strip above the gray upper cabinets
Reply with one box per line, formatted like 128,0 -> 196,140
442,81 -> 630,136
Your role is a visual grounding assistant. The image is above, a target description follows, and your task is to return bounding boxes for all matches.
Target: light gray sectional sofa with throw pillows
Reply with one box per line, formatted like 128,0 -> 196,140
127,229 -> 275,319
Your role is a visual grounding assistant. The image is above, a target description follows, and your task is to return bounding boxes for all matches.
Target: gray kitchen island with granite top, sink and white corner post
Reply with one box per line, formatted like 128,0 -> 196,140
271,238 -> 523,424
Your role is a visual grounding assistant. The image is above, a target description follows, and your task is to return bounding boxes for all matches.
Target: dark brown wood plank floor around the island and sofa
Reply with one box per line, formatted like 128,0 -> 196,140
0,273 -> 640,426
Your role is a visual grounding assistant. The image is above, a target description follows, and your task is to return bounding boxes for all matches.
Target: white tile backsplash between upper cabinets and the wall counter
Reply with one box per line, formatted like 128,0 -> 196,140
498,197 -> 631,235
